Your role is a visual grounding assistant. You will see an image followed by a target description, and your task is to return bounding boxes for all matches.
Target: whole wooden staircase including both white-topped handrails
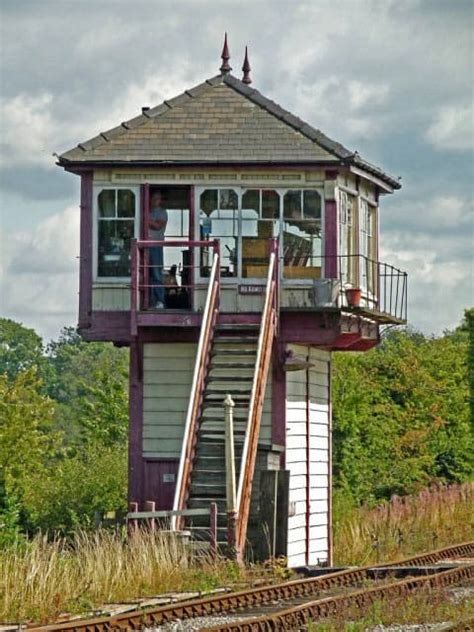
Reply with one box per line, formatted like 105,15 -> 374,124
172,240 -> 278,560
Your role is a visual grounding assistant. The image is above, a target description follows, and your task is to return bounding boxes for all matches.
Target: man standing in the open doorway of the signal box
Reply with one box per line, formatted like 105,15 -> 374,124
148,191 -> 168,309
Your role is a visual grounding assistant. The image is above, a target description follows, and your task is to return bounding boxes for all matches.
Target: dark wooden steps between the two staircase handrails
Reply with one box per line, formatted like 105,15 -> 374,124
185,325 -> 259,548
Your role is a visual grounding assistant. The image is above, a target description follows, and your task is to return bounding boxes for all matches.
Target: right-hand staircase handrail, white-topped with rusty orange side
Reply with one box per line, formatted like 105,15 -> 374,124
236,243 -> 278,557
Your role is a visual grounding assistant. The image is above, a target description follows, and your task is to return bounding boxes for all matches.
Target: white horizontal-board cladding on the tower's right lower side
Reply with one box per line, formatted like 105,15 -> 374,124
286,345 -> 330,567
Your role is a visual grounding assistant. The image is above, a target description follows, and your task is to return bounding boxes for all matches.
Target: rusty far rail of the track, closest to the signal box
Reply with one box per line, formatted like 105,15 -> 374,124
28,541 -> 474,632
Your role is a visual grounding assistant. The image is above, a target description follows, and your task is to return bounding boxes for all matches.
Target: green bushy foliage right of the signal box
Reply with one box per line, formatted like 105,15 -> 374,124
333,330 -> 473,503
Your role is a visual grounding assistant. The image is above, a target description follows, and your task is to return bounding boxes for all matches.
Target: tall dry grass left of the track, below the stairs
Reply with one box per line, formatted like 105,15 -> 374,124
0,530 -> 244,623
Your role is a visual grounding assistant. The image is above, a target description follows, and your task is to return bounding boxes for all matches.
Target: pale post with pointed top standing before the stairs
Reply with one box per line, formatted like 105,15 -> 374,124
224,393 -> 239,558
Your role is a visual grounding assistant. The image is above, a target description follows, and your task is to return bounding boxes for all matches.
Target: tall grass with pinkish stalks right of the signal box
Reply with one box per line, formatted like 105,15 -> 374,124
334,483 -> 474,564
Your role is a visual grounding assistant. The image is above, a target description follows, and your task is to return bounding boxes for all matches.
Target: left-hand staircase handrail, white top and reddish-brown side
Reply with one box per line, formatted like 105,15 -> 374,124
171,249 -> 220,530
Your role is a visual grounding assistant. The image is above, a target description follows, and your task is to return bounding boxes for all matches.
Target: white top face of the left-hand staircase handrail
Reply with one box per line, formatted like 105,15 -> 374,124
171,253 -> 219,531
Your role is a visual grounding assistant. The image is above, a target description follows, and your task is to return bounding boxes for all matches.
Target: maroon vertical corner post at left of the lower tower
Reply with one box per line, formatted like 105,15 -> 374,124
128,342 -> 145,504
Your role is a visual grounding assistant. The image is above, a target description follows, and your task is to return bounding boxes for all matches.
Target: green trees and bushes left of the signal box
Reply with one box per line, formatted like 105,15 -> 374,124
0,319 -> 128,532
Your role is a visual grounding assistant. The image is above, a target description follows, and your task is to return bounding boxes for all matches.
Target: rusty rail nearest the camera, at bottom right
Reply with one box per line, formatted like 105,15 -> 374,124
202,564 -> 474,632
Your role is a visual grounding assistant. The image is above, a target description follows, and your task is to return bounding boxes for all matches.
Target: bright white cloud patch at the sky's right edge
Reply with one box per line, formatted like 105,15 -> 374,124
426,104 -> 474,150
